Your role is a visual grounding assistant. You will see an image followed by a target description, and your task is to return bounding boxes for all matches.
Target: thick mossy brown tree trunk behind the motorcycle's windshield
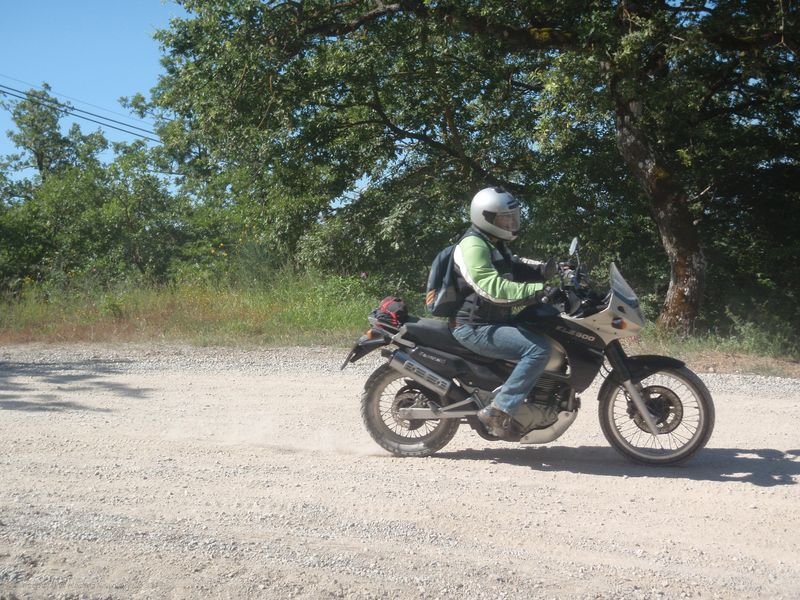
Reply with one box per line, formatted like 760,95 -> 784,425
614,95 -> 706,335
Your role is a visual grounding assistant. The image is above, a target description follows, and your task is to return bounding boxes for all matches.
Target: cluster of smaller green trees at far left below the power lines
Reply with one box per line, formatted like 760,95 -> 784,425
0,85 -> 189,287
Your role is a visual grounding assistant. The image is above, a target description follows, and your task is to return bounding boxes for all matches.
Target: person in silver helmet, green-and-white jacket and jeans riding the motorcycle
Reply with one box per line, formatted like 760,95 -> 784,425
453,188 -> 555,437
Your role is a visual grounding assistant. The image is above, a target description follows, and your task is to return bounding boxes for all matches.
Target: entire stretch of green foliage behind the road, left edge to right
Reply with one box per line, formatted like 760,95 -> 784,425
0,0 -> 800,352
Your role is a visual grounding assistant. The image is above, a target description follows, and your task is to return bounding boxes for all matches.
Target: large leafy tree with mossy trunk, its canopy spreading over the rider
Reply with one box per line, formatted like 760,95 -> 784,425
155,0 -> 798,332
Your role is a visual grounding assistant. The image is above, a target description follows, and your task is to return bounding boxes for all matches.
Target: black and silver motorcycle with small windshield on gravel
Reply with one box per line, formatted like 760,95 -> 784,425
341,238 -> 715,465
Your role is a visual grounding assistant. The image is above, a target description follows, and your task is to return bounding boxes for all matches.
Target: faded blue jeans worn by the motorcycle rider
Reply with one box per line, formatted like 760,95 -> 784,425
453,325 -> 550,416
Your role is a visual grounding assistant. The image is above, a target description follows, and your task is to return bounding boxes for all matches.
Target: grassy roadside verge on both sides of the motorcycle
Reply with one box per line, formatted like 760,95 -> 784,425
0,272 -> 800,378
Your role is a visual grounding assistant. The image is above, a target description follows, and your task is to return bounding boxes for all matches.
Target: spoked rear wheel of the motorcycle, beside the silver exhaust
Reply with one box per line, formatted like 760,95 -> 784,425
361,364 -> 459,456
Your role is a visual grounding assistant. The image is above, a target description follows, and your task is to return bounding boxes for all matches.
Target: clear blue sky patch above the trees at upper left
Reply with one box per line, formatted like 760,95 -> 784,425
0,0 -> 185,162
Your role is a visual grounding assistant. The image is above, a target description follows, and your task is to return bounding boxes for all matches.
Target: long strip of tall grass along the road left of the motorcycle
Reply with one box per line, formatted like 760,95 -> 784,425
0,274 -> 379,346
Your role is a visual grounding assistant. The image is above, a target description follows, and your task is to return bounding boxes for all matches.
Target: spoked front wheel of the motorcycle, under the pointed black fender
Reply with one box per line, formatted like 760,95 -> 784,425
598,367 -> 714,465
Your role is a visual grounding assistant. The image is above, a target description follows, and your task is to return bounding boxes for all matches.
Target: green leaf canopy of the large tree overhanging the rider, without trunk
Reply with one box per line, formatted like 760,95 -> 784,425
141,0 -> 797,336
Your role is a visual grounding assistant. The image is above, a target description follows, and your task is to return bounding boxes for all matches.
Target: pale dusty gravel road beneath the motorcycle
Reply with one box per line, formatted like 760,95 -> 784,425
0,345 -> 800,600
